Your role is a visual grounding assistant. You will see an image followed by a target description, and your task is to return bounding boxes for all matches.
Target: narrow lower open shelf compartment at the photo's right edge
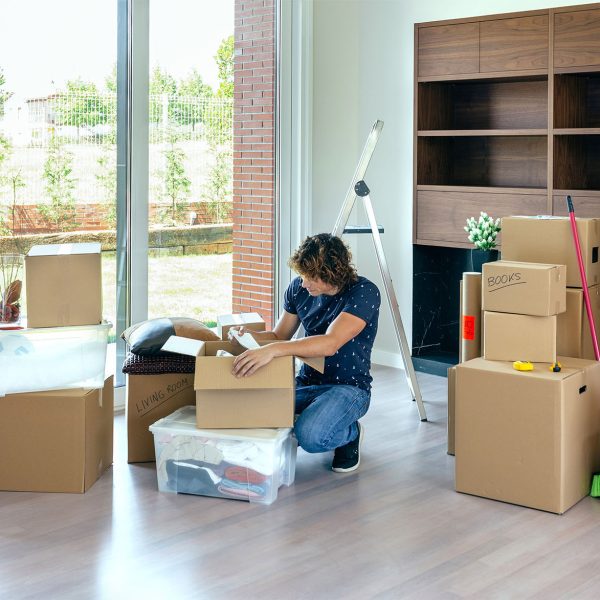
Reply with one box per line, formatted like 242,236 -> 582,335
554,135 -> 600,190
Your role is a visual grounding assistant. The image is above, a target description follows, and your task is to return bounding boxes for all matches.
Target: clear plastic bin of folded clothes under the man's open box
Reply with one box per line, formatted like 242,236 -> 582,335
150,406 -> 298,504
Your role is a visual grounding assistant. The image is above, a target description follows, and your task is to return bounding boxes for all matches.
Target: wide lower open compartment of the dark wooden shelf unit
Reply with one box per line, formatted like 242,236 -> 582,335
417,136 -> 548,188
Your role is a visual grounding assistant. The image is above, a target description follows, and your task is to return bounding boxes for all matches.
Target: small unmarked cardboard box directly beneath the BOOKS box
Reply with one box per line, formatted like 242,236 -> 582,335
483,311 -> 556,363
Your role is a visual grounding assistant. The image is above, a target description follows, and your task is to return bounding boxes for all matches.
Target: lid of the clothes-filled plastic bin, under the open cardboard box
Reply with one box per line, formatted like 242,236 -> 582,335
149,406 -> 291,442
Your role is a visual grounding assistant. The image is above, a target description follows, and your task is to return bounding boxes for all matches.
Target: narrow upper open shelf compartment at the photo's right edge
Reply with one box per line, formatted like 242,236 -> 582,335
554,72 -> 600,129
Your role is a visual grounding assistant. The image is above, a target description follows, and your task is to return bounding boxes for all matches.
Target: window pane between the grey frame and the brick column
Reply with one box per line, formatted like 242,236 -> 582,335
148,0 -> 234,325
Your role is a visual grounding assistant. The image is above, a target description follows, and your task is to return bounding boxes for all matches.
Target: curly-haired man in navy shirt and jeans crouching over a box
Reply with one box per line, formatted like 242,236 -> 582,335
233,233 -> 381,473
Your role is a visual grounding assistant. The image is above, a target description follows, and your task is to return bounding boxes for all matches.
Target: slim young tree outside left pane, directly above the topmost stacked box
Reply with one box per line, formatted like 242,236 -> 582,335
38,136 -> 79,231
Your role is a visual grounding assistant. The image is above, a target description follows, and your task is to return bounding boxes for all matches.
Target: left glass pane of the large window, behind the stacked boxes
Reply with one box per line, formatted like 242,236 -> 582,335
0,0 -> 117,338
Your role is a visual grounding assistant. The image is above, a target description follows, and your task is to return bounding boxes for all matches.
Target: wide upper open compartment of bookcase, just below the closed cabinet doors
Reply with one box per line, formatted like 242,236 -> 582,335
417,76 -> 548,130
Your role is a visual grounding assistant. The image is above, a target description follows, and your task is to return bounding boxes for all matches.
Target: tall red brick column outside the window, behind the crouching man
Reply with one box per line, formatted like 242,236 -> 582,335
232,0 -> 276,327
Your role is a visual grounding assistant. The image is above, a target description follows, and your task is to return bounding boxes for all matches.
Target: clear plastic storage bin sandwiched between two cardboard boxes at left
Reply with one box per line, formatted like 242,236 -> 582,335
0,323 -> 111,396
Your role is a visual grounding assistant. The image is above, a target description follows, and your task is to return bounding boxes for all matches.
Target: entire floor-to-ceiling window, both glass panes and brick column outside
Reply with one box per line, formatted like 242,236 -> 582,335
0,0 -> 276,392
